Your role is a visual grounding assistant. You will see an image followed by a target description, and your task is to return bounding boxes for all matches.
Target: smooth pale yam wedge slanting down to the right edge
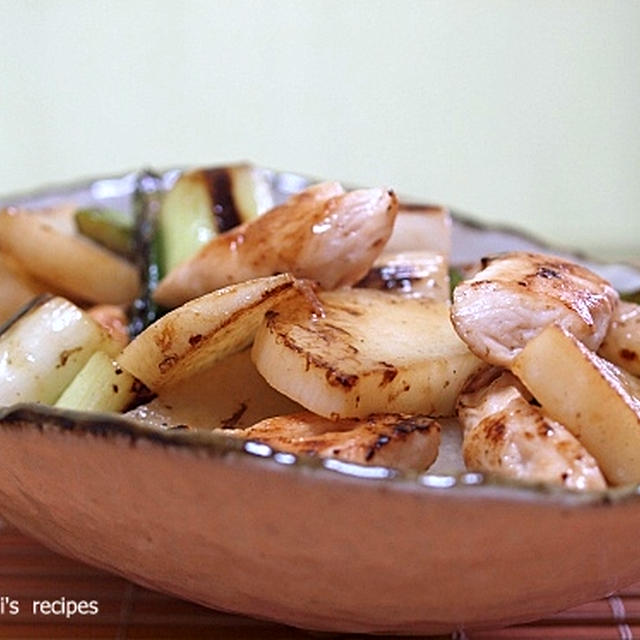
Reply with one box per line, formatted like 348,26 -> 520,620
513,325 -> 640,485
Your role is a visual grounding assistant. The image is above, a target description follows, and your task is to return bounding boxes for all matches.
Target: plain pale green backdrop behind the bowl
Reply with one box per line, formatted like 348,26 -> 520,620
0,0 -> 640,256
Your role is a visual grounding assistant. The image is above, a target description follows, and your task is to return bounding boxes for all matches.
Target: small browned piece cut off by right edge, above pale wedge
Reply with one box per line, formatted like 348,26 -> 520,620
598,301 -> 640,376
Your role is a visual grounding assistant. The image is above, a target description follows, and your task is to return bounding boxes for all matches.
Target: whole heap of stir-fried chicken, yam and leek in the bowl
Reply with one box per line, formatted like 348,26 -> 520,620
0,165 -> 640,490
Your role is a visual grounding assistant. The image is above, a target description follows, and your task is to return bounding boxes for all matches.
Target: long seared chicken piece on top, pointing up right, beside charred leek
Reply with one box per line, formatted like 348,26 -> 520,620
154,182 -> 398,307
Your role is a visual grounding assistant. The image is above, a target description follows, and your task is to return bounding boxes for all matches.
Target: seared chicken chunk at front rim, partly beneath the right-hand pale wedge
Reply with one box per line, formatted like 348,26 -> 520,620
458,370 -> 606,489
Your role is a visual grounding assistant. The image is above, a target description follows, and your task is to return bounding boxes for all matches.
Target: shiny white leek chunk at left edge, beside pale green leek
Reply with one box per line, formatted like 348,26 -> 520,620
0,297 -> 120,406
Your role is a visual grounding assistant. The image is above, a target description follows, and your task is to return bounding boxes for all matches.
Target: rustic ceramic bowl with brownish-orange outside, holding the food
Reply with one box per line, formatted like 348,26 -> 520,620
0,174 -> 640,634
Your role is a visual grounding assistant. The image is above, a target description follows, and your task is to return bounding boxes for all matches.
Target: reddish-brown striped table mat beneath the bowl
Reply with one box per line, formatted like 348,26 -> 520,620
0,525 -> 640,640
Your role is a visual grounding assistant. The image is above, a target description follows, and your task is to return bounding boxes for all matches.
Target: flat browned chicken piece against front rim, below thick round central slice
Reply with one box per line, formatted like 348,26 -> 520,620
216,411 -> 440,471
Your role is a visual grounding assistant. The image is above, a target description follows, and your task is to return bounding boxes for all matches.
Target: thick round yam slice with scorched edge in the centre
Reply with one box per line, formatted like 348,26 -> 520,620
253,289 -> 484,419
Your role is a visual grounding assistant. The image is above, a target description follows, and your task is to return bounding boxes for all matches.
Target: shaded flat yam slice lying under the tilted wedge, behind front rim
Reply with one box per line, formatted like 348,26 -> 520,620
128,349 -> 302,430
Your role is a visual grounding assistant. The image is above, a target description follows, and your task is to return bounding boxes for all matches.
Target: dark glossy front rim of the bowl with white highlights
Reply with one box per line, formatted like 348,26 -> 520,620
0,403 -> 640,508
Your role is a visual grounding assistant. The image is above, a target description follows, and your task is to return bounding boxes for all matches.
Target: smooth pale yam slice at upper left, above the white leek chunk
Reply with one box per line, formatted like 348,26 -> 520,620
0,209 -> 140,304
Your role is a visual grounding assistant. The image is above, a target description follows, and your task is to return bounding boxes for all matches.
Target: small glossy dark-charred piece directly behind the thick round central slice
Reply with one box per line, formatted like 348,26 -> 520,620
358,251 -> 450,302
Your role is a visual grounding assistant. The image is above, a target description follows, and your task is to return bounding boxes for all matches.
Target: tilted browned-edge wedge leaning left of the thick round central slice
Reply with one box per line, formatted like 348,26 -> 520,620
118,274 -> 303,391
